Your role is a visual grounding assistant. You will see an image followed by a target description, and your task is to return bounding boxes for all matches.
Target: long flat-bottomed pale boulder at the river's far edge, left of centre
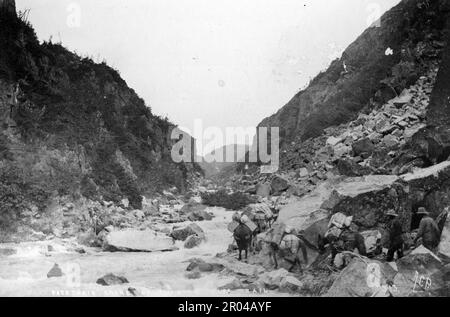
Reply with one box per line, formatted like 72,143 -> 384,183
103,229 -> 177,252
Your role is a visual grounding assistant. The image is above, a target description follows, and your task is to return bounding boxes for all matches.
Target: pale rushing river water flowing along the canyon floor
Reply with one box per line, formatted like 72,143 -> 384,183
0,208 -> 282,297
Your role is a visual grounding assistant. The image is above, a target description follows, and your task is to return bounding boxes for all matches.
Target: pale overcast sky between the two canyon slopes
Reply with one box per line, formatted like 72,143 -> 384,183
16,0 -> 400,153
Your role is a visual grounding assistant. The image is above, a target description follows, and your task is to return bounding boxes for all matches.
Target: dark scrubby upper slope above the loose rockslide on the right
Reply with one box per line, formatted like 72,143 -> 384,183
260,0 -> 448,144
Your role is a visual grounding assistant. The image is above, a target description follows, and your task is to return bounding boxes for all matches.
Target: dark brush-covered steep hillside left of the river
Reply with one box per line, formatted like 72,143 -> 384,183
0,1 -> 200,224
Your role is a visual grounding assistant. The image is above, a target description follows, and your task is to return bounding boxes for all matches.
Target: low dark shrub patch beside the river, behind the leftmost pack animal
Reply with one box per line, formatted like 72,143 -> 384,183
201,190 -> 254,210
